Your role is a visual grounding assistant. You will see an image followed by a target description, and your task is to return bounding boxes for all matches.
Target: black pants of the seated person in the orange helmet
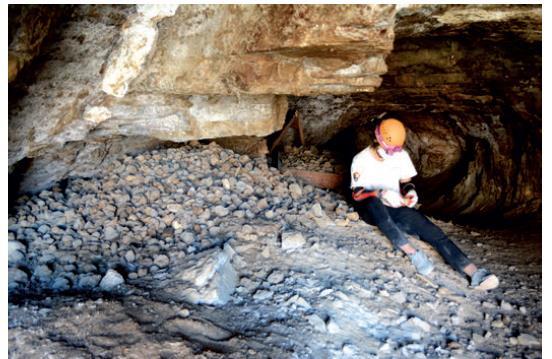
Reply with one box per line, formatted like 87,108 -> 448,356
355,197 -> 471,273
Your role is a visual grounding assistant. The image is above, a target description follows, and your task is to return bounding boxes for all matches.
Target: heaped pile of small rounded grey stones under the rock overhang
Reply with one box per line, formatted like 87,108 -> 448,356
8,143 -> 342,295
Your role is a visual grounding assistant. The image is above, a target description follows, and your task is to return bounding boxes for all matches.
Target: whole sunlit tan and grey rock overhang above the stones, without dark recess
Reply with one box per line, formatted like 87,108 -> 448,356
8,5 -> 395,191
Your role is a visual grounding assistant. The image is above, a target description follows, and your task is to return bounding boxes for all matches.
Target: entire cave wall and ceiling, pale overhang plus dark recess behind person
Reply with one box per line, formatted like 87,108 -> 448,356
8,5 -> 542,218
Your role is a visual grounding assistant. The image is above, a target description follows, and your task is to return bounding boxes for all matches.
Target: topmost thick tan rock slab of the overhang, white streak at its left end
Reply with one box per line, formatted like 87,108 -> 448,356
131,5 -> 395,95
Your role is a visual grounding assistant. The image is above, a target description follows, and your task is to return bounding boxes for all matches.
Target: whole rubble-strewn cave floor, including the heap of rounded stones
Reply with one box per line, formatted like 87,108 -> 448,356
8,144 -> 542,358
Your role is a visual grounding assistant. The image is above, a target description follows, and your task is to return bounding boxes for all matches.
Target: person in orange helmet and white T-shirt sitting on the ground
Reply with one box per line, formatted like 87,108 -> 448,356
351,118 -> 499,290
